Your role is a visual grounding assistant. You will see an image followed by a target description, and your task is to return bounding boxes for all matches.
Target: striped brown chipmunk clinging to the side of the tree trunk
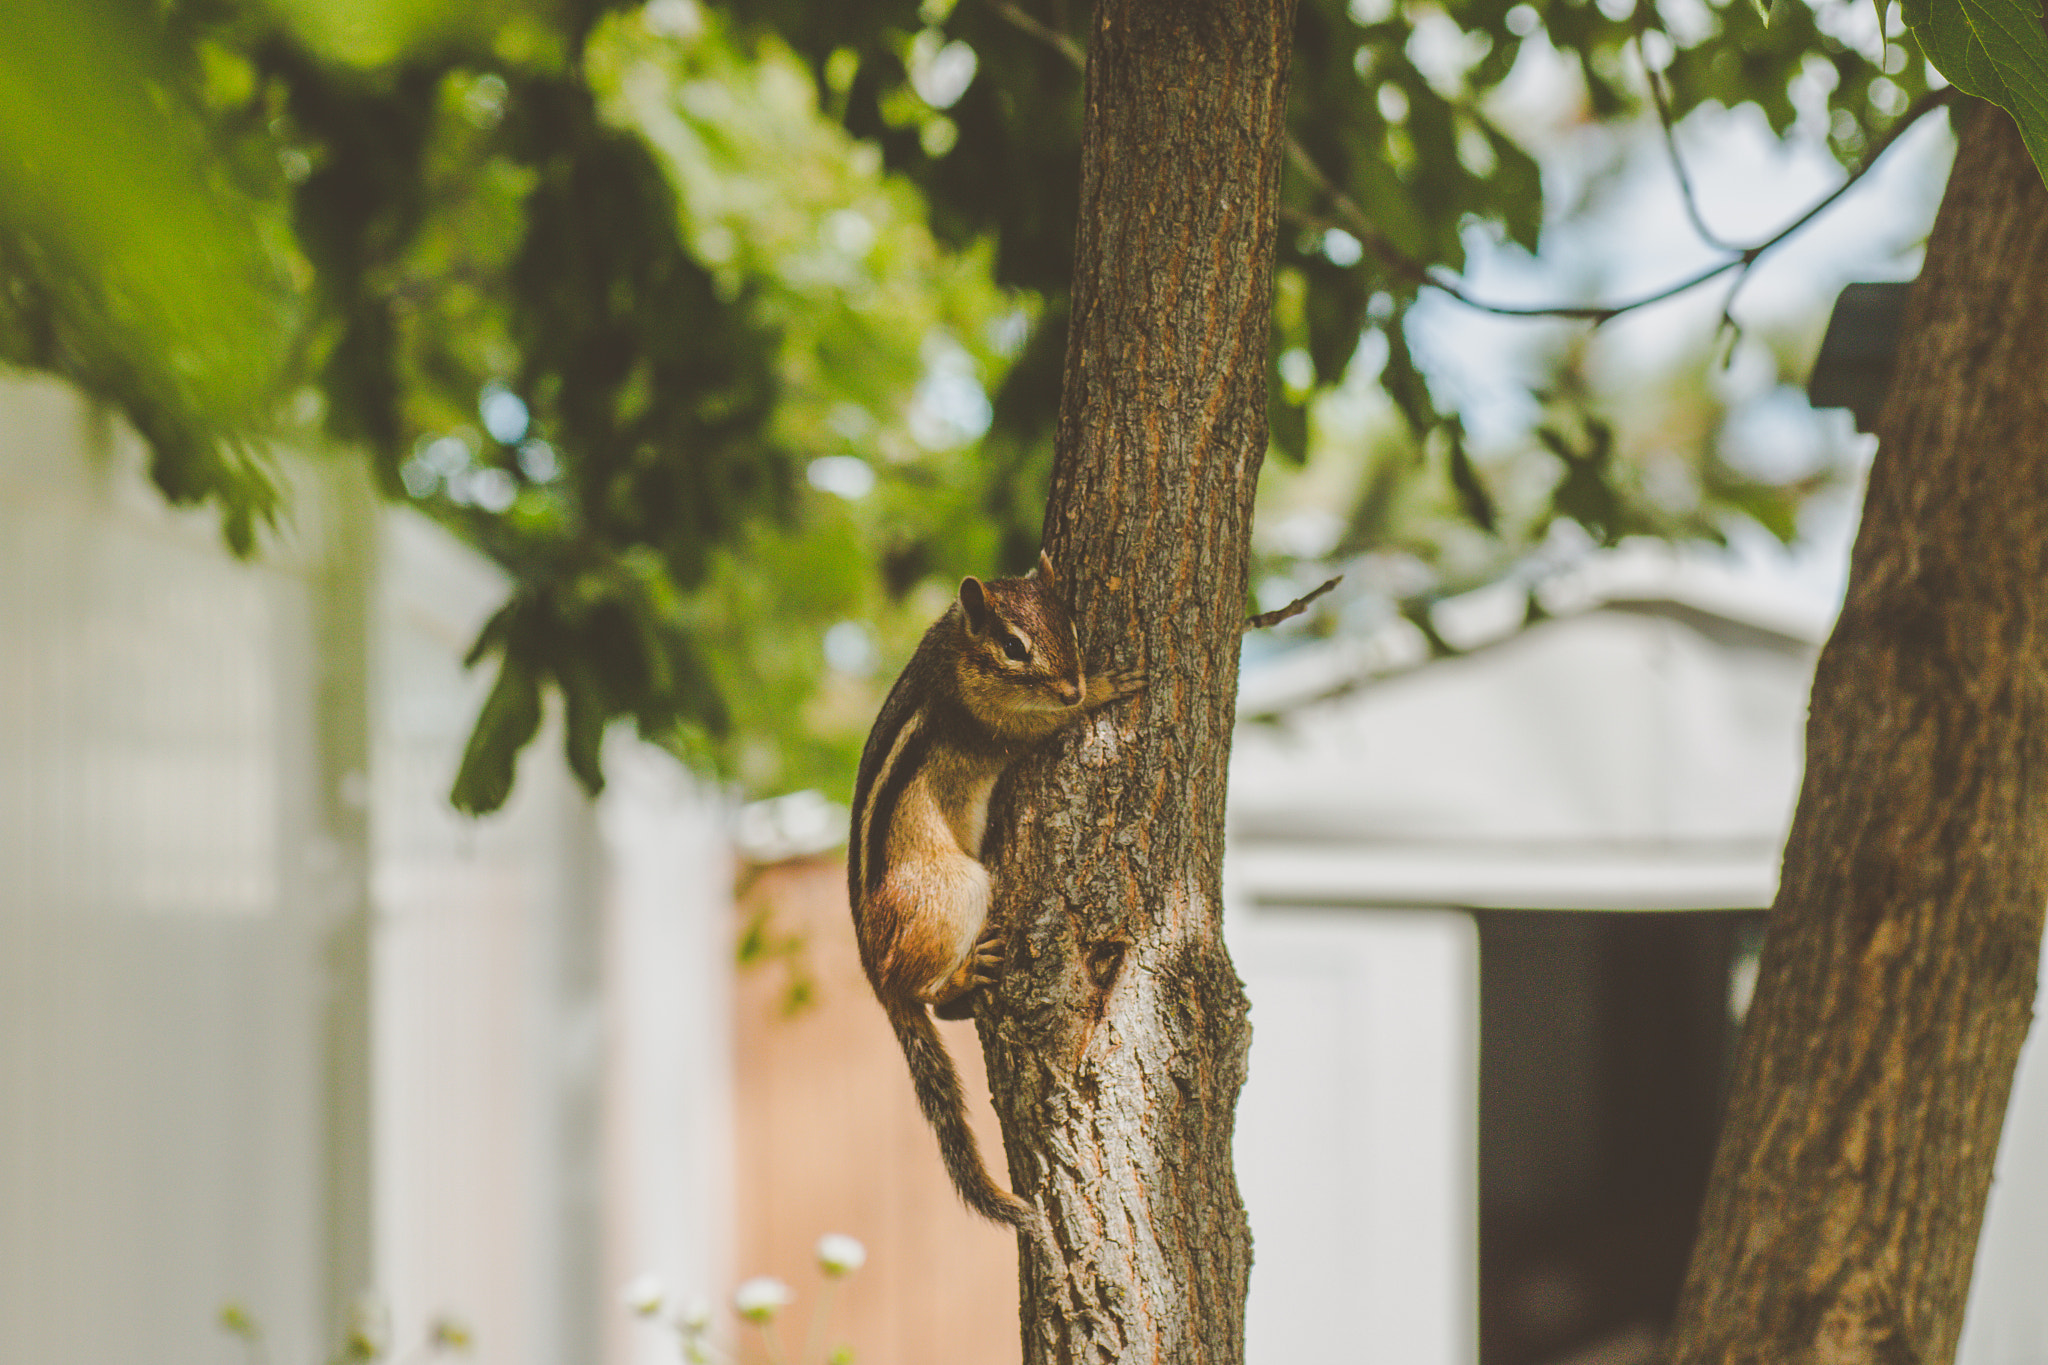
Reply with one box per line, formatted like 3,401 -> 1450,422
846,551 -> 1141,1228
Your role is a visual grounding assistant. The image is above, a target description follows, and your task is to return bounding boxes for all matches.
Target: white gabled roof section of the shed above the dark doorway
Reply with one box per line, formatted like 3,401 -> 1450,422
1229,555 -> 1827,909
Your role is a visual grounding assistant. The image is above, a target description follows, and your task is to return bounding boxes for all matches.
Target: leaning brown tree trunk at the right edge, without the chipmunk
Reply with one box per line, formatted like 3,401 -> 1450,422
1669,104 -> 2048,1365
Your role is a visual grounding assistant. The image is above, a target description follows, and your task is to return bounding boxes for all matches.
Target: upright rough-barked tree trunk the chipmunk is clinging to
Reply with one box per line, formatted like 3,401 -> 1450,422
983,0 -> 1294,1365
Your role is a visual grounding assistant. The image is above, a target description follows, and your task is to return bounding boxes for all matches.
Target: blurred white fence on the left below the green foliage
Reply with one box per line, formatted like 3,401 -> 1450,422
0,379 -> 729,1365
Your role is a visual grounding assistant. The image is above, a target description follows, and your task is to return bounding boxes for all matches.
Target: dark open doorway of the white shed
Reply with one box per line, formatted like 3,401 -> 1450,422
1477,911 -> 1761,1365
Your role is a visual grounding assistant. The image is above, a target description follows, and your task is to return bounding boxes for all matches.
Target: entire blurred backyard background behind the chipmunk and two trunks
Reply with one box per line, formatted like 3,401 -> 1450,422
0,0 -> 2048,1365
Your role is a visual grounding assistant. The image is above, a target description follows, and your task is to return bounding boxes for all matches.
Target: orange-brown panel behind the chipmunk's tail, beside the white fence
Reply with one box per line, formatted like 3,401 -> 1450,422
733,855 -> 1020,1365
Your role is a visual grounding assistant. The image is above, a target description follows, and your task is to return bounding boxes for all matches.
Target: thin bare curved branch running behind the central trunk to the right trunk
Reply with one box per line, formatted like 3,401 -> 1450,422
985,0 -> 1956,327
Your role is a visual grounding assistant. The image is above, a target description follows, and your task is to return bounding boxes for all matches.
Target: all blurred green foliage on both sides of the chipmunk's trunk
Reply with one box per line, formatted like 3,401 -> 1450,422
0,0 -> 1925,812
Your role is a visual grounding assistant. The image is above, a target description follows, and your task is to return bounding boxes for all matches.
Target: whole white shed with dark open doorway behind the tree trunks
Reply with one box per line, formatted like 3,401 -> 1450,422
1225,548 -> 2048,1365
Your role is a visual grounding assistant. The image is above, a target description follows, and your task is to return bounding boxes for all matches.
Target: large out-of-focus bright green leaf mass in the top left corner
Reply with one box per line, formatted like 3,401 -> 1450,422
0,4 -> 293,551
